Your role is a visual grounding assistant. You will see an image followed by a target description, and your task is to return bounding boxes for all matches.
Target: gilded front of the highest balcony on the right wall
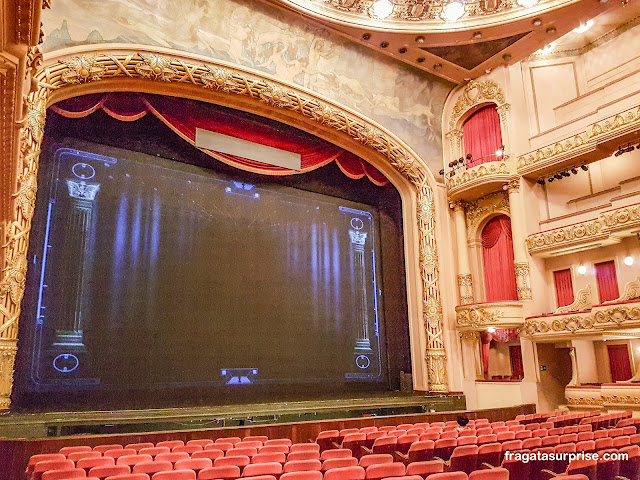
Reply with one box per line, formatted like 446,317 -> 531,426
518,106 -> 640,175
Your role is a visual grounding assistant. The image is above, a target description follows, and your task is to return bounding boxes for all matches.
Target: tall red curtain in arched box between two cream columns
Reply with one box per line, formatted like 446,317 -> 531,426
482,215 -> 518,302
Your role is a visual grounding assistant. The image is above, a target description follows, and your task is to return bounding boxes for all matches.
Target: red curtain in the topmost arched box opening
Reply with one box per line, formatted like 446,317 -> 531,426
462,105 -> 502,168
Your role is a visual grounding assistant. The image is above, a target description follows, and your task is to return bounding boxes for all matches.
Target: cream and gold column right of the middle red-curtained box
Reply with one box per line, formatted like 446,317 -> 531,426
503,179 -> 532,300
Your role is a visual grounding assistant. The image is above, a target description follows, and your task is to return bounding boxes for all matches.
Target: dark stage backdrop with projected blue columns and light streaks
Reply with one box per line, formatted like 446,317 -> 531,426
16,107 -> 408,408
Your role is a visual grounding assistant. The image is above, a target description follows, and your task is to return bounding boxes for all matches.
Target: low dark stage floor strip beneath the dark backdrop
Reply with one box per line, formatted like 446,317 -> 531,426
0,394 -> 466,438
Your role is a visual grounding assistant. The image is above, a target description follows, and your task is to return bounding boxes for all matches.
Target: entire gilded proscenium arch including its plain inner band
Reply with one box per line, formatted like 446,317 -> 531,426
0,45 -> 448,409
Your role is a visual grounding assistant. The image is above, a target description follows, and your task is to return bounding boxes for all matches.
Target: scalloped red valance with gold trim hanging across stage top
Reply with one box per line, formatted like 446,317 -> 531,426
51,93 -> 389,186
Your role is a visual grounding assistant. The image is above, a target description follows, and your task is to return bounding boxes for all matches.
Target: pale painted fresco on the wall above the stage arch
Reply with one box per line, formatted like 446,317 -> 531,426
42,0 -> 452,176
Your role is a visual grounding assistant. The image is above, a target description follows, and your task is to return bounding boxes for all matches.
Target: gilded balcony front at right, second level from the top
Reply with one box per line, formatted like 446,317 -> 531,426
527,204 -> 640,255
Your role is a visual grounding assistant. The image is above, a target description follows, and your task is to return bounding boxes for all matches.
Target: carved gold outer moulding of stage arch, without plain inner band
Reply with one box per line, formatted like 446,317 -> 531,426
0,49 -> 448,407
